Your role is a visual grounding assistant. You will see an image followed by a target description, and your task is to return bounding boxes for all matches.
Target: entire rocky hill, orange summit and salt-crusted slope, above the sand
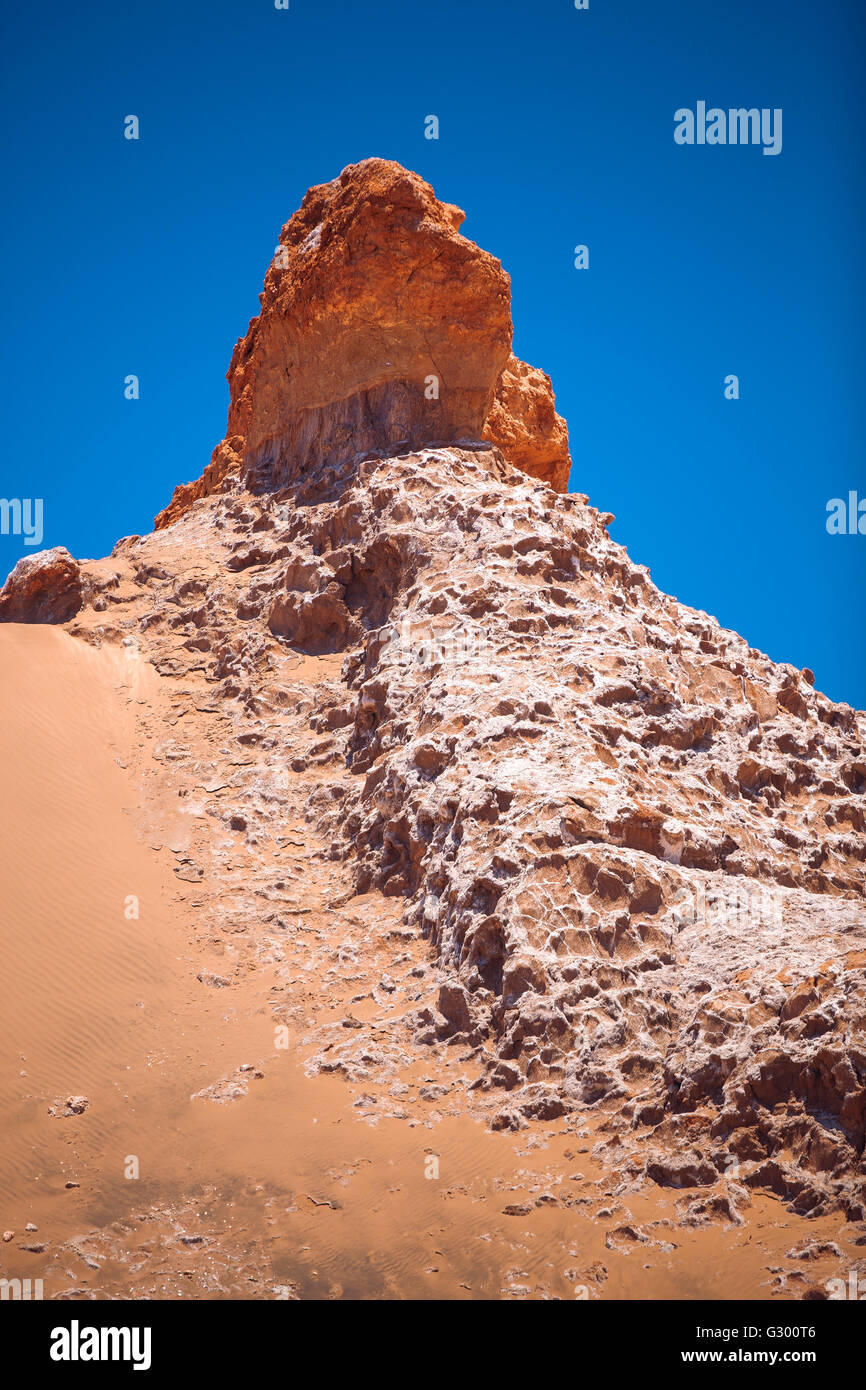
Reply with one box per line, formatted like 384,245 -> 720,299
0,160 -> 866,1220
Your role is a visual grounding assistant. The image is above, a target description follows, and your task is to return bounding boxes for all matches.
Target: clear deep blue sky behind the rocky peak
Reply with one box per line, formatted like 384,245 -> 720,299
0,0 -> 866,708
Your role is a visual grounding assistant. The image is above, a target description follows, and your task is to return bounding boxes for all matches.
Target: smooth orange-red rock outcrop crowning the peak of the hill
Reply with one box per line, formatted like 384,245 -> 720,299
156,160 -> 569,528
